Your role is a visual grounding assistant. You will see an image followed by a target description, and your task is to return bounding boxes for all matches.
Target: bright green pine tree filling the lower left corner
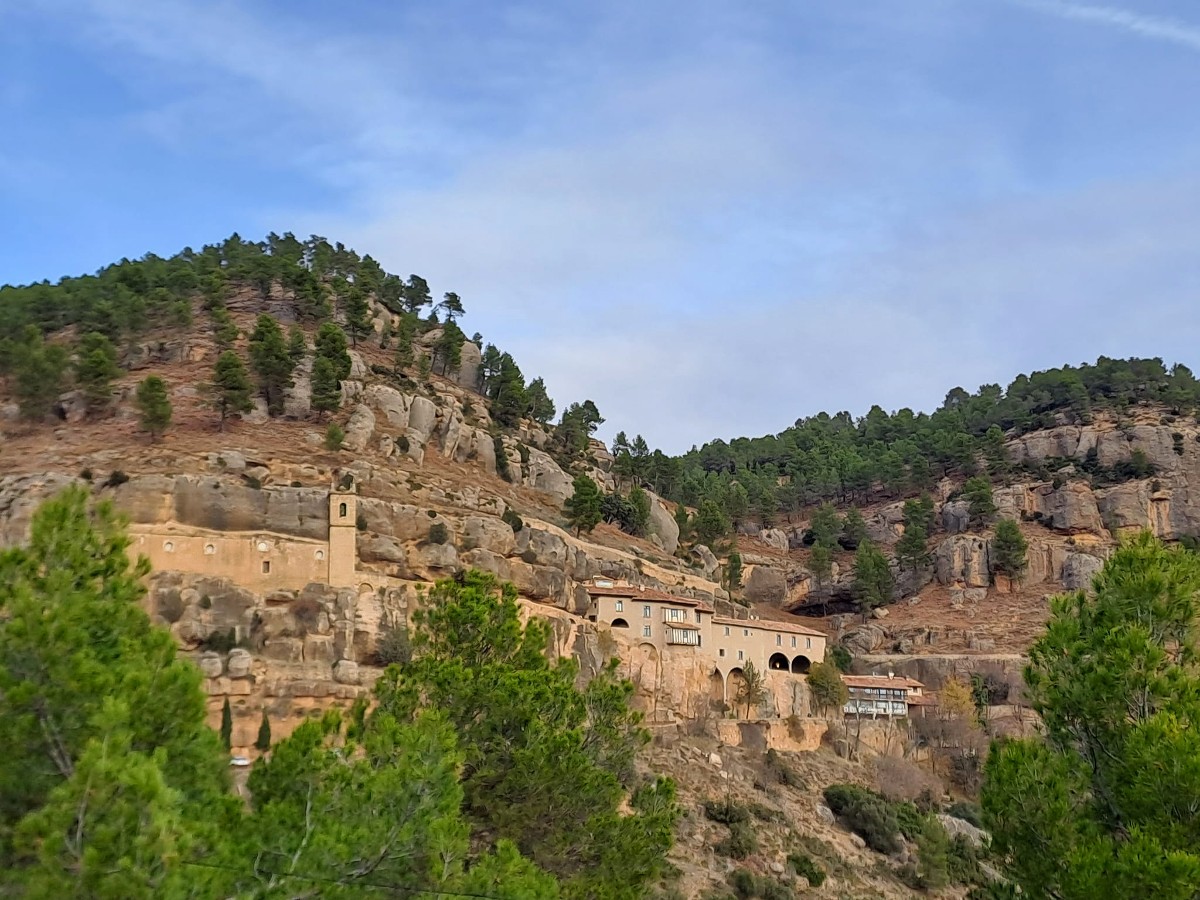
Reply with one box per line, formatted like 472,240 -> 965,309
0,487 -> 238,900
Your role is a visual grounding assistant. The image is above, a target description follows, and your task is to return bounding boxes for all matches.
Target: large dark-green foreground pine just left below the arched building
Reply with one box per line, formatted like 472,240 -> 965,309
372,571 -> 677,899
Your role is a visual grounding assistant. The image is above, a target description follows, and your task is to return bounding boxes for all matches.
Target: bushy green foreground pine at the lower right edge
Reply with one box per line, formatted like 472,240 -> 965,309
982,534 -> 1200,900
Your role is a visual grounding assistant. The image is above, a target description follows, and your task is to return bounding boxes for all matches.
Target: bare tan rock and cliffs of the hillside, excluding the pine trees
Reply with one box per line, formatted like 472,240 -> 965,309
0,234 -> 1200,896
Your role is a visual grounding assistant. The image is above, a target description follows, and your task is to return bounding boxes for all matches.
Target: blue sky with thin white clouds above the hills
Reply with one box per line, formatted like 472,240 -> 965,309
0,0 -> 1200,452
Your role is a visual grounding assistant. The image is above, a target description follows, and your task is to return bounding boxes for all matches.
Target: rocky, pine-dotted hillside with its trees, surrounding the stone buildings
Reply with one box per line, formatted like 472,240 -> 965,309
0,235 -> 1200,896
